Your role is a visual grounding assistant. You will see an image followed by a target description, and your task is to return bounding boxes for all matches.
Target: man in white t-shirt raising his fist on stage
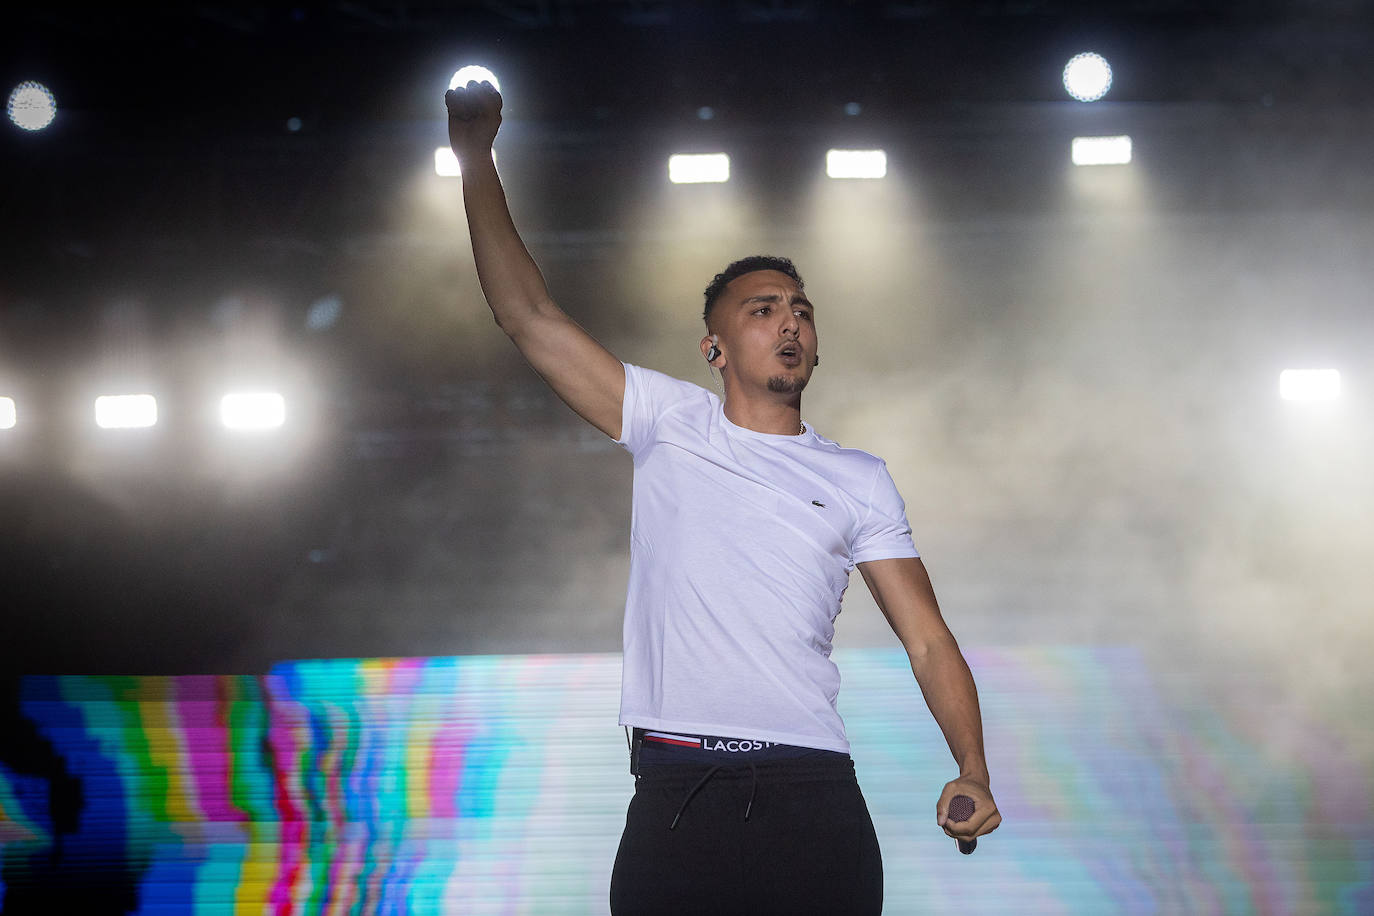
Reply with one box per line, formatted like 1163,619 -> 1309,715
445,82 -> 1002,913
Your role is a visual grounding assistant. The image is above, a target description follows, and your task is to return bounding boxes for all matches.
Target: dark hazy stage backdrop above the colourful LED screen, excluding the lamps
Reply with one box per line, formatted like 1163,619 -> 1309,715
0,0 -> 1374,696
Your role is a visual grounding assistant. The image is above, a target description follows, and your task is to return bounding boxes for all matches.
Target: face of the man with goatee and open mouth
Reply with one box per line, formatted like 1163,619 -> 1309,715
712,271 -> 816,394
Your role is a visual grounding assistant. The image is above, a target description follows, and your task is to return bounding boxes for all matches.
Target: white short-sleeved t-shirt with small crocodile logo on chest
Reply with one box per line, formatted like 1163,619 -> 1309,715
618,365 -> 918,753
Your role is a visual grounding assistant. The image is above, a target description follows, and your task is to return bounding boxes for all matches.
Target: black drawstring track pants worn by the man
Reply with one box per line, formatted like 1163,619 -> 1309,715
610,758 -> 882,916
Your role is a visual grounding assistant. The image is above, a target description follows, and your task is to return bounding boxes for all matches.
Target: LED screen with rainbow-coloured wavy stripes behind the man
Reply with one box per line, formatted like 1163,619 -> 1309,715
0,648 -> 1374,915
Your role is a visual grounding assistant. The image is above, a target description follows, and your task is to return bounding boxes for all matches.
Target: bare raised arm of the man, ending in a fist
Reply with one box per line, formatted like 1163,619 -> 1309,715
444,82 -> 625,439
